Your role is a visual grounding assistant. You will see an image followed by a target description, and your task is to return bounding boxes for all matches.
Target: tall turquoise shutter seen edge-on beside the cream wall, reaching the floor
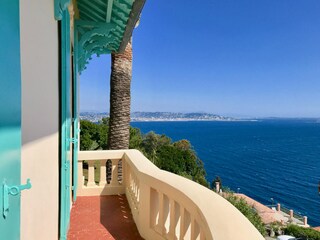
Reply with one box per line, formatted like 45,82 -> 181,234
60,10 -> 71,240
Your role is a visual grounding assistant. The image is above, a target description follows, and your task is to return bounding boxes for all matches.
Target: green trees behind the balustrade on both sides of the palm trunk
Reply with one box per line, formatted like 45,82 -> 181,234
80,121 -> 208,187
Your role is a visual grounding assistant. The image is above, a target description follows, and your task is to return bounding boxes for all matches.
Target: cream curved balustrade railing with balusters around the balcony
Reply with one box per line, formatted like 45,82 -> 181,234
78,150 -> 264,240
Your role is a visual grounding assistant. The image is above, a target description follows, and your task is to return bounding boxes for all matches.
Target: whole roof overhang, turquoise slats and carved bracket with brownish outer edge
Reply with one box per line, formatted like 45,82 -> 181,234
55,0 -> 146,72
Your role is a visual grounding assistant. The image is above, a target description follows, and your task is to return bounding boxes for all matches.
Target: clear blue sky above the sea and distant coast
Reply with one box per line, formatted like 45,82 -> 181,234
80,0 -> 320,117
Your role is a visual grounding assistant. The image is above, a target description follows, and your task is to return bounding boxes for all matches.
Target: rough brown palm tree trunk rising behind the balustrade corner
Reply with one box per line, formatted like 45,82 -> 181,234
108,41 -> 132,149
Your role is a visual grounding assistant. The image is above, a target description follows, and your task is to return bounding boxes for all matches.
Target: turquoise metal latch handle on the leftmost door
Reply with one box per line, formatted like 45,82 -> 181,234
2,178 -> 31,218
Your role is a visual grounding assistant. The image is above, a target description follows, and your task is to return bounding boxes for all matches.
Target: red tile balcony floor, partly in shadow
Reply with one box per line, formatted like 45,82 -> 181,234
68,195 -> 143,240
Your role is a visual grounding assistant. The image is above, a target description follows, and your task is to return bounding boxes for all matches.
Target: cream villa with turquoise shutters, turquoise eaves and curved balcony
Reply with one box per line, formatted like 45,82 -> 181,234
0,0 -> 316,240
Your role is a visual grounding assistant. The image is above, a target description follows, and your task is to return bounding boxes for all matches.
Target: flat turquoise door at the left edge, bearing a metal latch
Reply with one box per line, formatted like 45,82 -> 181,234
0,0 -> 21,240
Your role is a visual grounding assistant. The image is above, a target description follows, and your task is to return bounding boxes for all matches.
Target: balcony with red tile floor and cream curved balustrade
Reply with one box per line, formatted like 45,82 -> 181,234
68,150 -> 263,240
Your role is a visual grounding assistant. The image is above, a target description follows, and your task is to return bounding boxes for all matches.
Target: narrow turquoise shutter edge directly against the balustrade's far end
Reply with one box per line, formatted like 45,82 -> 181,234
72,26 -> 79,201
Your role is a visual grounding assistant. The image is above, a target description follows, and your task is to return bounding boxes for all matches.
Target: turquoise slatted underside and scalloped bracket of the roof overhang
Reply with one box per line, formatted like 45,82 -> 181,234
77,0 -> 134,72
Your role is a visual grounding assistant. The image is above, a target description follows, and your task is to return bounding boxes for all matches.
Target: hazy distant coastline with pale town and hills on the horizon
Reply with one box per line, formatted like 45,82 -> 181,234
80,112 -> 236,122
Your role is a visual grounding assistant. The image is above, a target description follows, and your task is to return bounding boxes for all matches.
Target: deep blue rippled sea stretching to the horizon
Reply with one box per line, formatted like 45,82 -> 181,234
132,120 -> 320,226
